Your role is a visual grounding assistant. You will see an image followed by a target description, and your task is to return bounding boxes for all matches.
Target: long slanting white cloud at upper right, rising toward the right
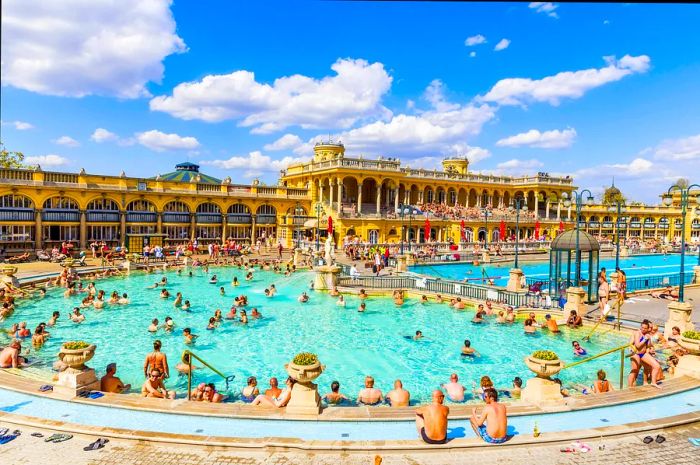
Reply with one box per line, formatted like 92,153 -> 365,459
480,55 -> 650,105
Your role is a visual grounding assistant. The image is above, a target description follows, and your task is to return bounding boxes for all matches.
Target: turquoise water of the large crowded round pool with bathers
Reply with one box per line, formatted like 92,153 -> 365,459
0,268 -> 627,401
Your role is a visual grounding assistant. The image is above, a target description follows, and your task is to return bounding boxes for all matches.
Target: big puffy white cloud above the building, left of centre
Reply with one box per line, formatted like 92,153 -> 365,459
150,59 -> 392,134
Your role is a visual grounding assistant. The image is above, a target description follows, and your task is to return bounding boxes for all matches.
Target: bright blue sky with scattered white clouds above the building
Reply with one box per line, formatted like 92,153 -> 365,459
0,0 -> 700,203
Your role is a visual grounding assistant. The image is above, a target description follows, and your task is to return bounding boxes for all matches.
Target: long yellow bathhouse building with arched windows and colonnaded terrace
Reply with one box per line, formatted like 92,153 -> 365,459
0,142 -> 700,251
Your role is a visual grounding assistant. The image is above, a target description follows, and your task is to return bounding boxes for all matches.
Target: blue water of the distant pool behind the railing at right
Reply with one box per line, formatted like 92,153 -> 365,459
410,254 -> 697,286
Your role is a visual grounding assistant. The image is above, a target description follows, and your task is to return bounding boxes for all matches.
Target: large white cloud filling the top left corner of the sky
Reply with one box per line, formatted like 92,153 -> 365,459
2,0 -> 186,98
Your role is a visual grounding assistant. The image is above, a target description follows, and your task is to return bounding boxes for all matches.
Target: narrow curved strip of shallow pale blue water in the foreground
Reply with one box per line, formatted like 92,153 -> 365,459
0,389 -> 700,441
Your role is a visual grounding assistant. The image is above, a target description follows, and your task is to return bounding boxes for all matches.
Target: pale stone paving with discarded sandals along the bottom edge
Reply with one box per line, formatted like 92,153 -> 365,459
0,423 -> 700,465
